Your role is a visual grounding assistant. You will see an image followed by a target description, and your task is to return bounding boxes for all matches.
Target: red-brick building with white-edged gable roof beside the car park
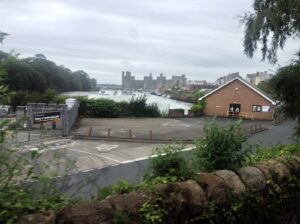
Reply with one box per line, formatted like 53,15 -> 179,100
199,77 -> 276,120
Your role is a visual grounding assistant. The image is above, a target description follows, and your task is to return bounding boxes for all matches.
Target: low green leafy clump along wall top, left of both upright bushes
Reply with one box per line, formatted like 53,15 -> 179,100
96,180 -> 136,200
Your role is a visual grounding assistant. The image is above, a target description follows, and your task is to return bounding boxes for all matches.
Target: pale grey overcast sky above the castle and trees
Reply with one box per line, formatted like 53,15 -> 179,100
0,0 -> 298,84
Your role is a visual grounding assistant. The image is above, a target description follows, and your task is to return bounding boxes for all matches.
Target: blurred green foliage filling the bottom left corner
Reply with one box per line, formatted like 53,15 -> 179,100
0,145 -> 74,223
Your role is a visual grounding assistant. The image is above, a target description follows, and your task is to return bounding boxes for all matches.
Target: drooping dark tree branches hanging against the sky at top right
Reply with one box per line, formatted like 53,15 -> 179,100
241,0 -> 300,64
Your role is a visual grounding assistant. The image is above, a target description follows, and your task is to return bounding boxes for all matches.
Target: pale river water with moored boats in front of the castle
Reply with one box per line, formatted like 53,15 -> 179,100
63,90 -> 192,114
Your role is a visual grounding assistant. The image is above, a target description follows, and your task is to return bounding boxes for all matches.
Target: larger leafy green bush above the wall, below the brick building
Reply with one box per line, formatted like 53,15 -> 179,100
194,119 -> 248,171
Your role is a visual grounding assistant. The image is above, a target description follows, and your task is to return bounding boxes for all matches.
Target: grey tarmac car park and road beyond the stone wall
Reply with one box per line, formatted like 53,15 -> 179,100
12,119 -> 296,196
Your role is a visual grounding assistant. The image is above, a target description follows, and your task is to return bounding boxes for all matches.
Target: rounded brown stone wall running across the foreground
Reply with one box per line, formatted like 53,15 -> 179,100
18,157 -> 300,224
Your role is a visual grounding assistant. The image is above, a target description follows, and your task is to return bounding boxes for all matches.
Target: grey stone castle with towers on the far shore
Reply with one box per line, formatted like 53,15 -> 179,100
122,71 -> 187,91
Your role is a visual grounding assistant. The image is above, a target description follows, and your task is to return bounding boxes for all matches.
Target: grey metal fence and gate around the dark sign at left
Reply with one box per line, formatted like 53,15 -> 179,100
0,100 -> 79,143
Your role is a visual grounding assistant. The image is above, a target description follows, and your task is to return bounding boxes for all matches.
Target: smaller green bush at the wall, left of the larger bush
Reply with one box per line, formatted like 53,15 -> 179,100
145,144 -> 194,182
